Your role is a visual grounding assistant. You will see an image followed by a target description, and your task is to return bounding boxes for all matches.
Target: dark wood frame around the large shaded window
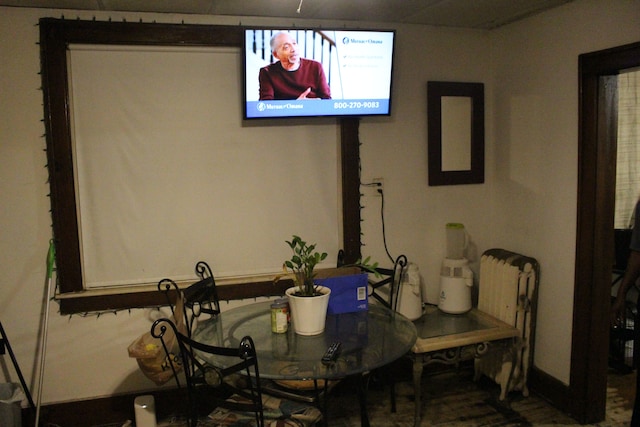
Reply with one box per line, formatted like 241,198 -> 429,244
40,18 -> 360,314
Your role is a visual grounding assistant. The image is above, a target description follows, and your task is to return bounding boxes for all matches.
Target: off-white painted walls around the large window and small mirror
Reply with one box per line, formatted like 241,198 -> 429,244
0,0 -> 640,403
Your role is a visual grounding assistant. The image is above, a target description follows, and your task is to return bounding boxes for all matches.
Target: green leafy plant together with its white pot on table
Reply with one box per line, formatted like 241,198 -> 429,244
283,235 -> 331,335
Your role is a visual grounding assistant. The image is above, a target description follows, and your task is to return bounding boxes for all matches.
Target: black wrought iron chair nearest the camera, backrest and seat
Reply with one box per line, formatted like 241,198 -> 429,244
151,318 -> 322,427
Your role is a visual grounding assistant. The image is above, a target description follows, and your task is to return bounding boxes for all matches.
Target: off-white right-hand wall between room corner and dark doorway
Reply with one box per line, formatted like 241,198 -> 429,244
492,0 -> 640,383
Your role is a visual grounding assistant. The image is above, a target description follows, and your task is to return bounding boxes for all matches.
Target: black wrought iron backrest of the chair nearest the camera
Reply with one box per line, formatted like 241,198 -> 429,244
151,318 -> 264,427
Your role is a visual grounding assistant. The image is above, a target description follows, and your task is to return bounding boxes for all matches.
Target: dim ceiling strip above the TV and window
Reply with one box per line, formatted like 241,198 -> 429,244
0,0 -> 572,29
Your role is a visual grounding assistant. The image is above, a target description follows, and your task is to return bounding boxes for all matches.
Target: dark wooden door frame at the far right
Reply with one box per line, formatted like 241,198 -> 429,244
568,43 -> 640,423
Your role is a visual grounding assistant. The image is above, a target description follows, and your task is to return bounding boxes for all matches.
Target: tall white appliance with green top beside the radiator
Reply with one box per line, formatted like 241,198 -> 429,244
438,223 -> 473,314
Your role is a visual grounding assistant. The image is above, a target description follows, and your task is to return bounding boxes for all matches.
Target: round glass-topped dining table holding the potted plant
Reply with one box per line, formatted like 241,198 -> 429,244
193,301 -> 417,427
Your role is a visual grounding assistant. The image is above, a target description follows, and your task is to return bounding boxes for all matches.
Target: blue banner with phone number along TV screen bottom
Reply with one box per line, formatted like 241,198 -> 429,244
247,99 -> 389,118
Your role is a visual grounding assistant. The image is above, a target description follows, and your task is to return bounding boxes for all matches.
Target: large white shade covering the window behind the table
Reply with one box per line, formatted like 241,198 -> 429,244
69,45 -> 341,289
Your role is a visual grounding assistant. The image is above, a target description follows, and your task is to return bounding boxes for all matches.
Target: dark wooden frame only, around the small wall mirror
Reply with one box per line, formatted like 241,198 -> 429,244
427,82 -> 484,186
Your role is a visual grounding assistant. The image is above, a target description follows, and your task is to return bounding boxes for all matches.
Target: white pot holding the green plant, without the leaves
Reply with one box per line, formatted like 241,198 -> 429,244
285,286 -> 331,335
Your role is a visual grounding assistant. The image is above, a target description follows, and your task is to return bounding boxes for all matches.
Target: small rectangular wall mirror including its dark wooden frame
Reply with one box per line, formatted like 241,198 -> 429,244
427,82 -> 484,186
